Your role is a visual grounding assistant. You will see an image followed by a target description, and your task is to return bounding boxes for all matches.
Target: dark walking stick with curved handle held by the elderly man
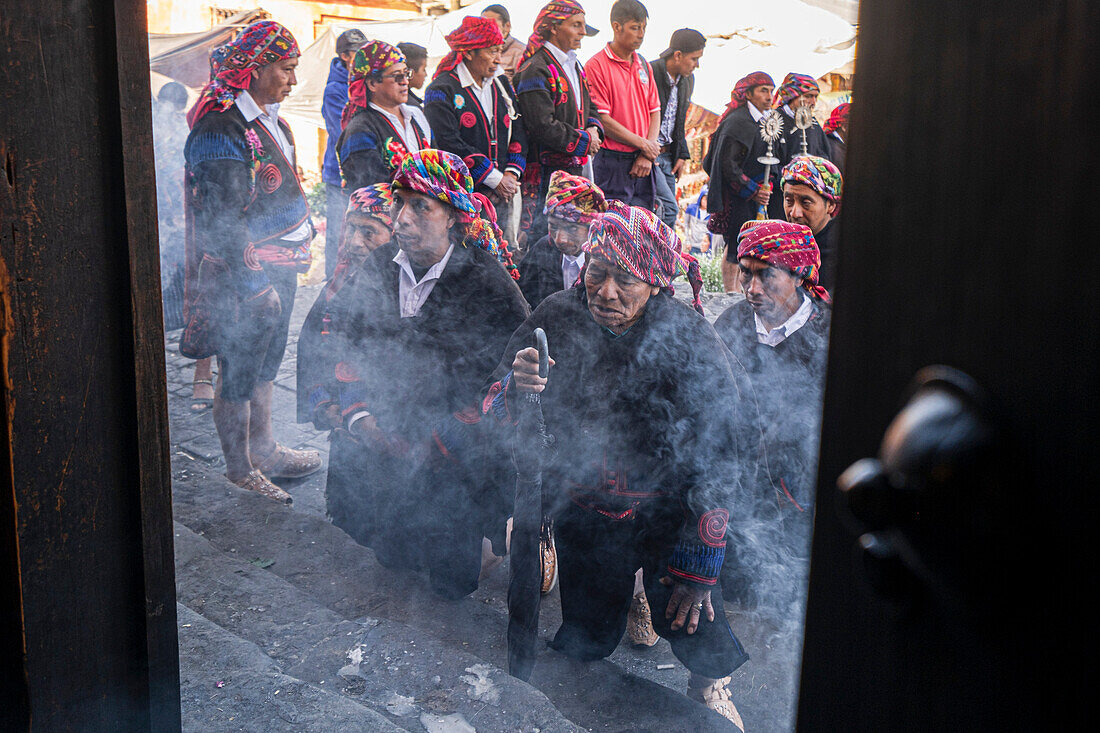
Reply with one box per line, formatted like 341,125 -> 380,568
508,328 -> 554,681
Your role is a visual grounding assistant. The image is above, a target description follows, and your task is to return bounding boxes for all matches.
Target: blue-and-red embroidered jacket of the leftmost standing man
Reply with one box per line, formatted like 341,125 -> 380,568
184,105 -> 309,293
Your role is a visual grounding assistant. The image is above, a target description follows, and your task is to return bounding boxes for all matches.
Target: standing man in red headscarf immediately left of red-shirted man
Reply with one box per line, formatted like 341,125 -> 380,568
515,0 -> 604,244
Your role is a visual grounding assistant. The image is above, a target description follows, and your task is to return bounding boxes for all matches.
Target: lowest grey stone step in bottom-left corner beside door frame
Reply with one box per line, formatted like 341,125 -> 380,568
176,603 -> 404,733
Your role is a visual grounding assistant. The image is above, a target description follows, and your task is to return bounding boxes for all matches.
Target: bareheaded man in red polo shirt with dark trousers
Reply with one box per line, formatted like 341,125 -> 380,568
584,0 -> 661,211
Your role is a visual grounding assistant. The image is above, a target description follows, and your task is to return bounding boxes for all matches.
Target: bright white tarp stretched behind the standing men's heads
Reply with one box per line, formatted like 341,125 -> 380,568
281,0 -> 856,128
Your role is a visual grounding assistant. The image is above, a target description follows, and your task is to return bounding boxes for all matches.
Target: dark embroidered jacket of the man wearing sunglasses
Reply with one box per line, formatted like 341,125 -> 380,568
337,106 -> 431,192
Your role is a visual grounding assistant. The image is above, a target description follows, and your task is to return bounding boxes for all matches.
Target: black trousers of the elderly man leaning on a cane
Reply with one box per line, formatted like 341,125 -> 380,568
550,503 -> 749,679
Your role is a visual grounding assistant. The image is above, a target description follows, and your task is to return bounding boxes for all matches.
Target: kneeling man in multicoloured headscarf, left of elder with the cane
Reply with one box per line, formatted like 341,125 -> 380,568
326,149 -> 528,599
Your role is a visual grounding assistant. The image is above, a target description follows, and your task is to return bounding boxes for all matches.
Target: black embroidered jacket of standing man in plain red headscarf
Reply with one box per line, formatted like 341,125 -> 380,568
424,70 -> 527,185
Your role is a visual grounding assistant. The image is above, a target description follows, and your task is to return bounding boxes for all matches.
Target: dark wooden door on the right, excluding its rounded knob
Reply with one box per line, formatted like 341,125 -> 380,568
799,0 -> 1100,731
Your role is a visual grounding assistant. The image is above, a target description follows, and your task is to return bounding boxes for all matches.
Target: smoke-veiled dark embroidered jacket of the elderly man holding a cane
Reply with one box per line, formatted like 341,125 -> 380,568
482,285 -> 756,586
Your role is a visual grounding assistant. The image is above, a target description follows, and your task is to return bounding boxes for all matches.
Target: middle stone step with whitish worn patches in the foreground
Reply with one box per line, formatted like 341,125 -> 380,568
175,519 -> 581,733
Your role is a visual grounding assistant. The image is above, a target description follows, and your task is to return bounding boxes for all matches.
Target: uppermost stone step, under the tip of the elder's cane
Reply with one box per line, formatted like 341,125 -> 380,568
174,453 -> 739,732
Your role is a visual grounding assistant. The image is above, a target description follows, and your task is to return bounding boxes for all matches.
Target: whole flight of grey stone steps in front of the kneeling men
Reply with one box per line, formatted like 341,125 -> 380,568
174,458 -> 756,731
